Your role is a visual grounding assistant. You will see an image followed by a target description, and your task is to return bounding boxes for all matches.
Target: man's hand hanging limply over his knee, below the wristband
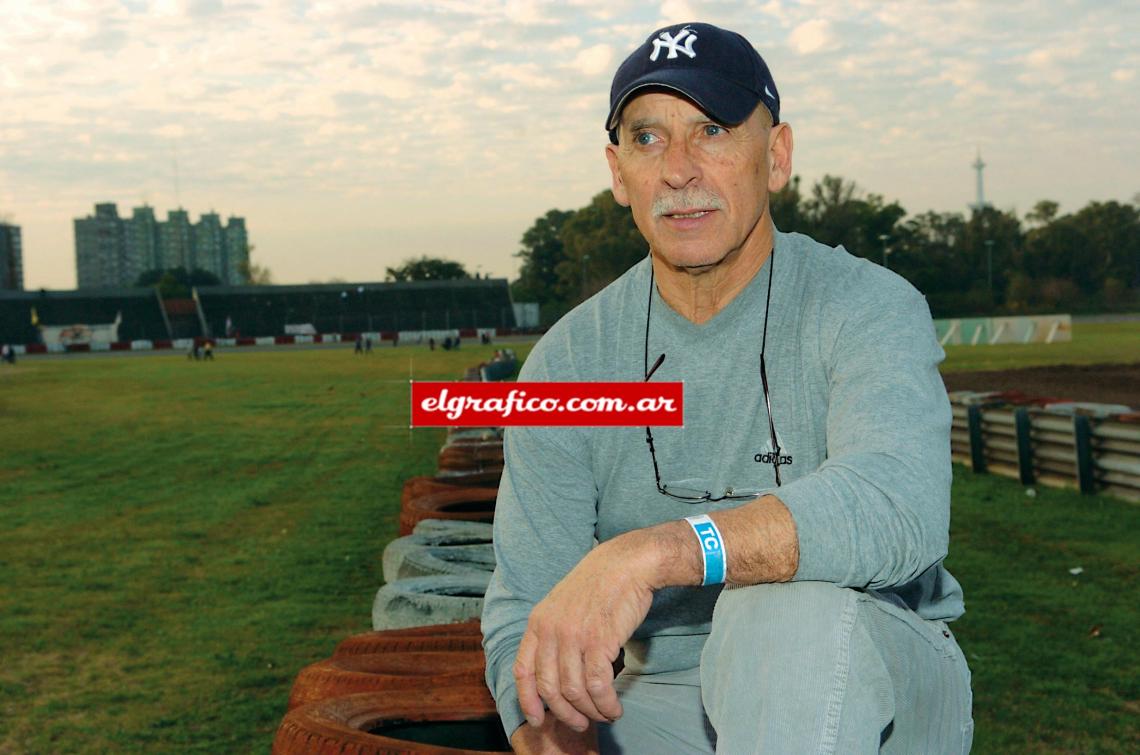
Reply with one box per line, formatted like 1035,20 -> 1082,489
514,530 -> 661,731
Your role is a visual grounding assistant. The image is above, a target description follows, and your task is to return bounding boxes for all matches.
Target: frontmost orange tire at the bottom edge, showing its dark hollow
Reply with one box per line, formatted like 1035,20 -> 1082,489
272,685 -> 511,755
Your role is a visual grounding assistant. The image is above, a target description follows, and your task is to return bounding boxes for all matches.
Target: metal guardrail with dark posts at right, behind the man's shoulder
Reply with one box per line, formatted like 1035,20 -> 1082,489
950,391 -> 1140,501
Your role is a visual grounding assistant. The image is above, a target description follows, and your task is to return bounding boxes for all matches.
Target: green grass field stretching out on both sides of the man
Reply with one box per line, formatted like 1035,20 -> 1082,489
0,326 -> 1140,754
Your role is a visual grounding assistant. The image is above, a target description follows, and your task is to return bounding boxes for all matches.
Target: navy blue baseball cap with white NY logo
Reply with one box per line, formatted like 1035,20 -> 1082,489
605,23 -> 780,144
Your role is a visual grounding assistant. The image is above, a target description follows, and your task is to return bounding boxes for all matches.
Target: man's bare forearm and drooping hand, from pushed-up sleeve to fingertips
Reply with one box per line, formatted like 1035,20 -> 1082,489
514,495 -> 799,731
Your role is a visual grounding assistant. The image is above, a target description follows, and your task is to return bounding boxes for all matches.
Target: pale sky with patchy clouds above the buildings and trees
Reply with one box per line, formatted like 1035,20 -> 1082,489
0,0 -> 1140,289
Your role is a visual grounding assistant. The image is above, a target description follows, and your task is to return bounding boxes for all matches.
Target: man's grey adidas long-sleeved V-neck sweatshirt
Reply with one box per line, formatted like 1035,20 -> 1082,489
482,233 -> 963,733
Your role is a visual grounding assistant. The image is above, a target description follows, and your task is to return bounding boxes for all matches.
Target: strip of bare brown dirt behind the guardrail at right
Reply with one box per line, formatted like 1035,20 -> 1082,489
942,364 -> 1140,408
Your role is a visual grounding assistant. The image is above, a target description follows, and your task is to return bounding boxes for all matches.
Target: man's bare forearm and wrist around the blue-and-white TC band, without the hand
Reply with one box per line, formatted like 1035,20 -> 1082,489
628,495 -> 799,590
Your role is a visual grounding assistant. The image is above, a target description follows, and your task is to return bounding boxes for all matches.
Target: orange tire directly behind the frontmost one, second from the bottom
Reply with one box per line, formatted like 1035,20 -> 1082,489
288,650 -> 486,711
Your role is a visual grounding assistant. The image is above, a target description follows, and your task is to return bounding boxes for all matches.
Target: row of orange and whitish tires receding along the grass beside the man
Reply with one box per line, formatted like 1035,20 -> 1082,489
272,371 -> 510,755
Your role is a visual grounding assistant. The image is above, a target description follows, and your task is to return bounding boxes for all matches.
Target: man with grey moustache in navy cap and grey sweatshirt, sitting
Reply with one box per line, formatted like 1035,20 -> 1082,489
483,23 -> 972,755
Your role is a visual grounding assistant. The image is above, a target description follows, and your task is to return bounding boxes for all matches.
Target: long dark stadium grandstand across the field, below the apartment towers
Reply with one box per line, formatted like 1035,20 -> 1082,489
0,278 -> 515,344
